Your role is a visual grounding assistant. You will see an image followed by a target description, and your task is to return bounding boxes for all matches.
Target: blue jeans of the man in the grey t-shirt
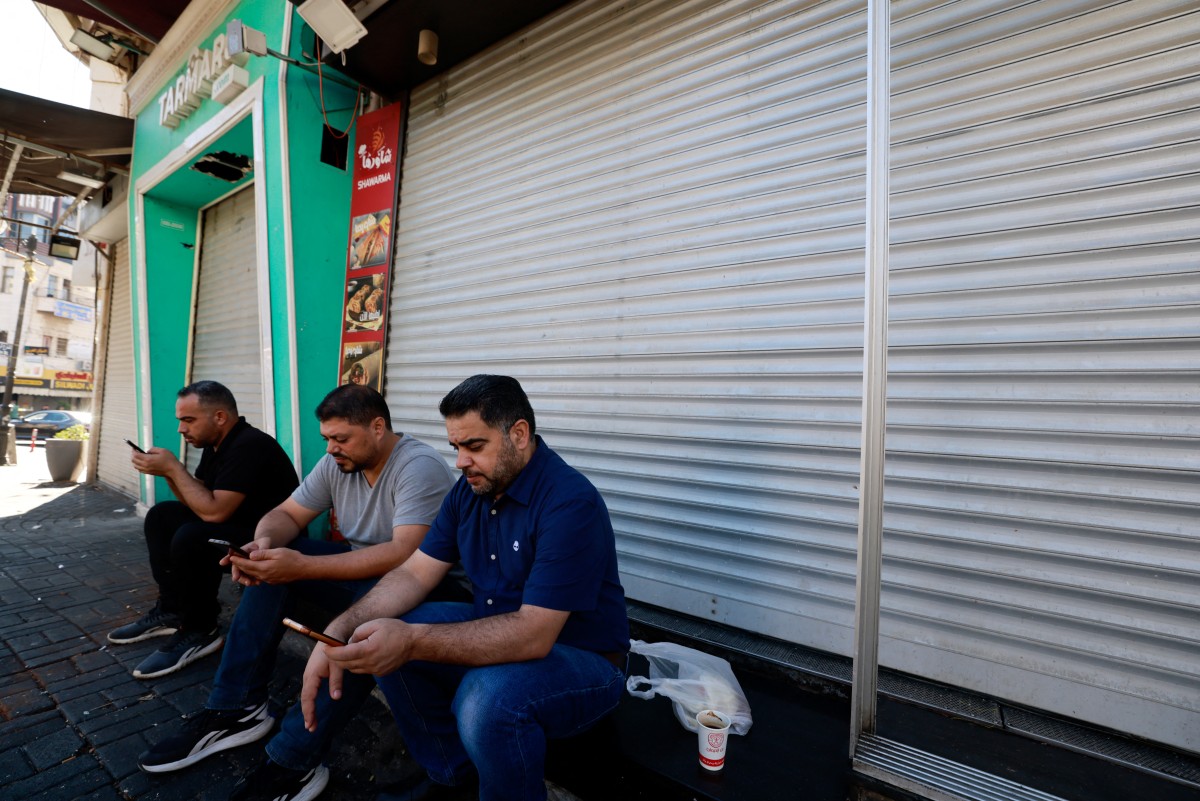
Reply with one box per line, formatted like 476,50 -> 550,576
205,538 -> 378,770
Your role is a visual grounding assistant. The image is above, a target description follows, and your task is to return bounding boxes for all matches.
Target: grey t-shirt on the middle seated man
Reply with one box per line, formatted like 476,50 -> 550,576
292,434 -> 454,548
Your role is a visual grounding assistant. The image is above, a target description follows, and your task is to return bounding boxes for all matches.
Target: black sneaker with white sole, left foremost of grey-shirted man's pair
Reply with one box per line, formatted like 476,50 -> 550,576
138,703 -> 275,773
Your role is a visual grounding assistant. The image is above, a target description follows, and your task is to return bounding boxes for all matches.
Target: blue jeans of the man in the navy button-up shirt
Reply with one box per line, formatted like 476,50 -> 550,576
376,603 -> 625,801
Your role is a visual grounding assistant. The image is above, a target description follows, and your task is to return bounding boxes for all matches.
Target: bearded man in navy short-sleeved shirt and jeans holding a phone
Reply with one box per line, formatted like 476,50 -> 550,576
301,375 -> 629,801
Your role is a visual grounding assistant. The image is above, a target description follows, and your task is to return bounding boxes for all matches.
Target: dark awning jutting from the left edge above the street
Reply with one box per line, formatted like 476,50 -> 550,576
0,89 -> 133,195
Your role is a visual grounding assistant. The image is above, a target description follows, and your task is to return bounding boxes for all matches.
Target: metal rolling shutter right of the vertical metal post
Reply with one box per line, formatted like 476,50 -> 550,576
881,0 -> 1200,751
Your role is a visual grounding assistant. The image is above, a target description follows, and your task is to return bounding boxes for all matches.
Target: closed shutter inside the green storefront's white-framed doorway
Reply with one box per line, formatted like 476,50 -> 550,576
186,186 -> 263,471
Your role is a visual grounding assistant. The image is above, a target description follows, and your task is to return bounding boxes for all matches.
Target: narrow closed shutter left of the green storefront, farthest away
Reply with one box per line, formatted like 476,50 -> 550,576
96,240 -> 139,498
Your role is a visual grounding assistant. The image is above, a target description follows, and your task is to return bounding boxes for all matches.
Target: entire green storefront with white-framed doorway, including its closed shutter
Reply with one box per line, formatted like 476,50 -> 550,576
113,0 -> 358,505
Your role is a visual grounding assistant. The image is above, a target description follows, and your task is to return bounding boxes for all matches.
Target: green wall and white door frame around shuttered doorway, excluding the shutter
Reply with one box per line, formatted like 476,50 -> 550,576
130,0 -> 356,504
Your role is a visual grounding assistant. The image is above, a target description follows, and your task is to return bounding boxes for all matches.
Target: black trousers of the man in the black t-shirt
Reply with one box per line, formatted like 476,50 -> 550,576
144,501 -> 254,632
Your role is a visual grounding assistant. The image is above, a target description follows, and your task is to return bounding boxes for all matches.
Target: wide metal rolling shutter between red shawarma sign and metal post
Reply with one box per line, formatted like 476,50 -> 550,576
386,0 -> 865,654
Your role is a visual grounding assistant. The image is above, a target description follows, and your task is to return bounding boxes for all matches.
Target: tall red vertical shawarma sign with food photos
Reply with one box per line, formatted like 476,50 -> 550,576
338,103 -> 401,392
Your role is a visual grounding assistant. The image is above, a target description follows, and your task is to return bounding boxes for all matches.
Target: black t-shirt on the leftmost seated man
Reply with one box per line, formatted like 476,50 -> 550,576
196,417 -> 300,529
